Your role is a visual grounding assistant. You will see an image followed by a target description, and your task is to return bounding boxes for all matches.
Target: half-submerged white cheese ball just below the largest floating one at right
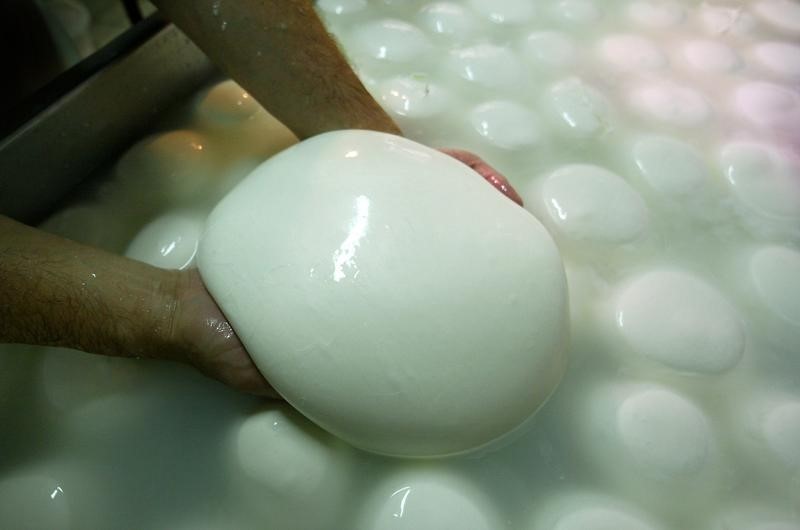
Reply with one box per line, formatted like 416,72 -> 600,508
565,378 -> 729,514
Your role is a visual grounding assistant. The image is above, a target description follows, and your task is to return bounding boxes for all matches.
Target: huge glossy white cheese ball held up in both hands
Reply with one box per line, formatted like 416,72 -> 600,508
203,131 -> 568,456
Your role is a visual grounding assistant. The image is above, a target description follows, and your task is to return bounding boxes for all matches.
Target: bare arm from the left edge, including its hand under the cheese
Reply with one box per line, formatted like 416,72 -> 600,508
0,215 -> 274,396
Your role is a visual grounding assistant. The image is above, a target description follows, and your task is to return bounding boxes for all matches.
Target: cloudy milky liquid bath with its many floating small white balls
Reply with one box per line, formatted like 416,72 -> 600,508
0,0 -> 800,530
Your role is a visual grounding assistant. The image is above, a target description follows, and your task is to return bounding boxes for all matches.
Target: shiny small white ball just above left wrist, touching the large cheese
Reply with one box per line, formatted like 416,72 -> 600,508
125,213 -> 204,270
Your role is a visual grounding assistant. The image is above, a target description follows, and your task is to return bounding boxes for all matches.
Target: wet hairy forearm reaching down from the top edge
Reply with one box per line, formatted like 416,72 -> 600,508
154,0 -> 400,139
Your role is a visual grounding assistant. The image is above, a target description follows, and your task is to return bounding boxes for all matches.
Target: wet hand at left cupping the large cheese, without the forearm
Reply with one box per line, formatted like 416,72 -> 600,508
170,269 -> 280,399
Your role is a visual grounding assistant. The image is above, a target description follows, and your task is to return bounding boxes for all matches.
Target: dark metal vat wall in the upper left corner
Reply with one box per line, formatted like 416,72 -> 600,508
0,18 -> 215,223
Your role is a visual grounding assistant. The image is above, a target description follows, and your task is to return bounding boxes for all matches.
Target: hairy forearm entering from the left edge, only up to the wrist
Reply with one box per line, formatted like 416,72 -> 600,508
0,216 -> 178,357
